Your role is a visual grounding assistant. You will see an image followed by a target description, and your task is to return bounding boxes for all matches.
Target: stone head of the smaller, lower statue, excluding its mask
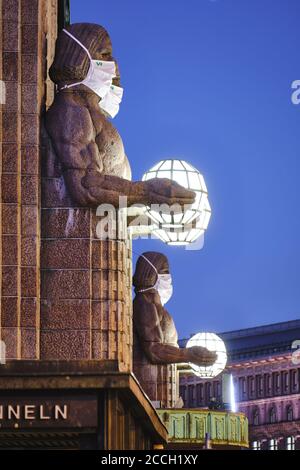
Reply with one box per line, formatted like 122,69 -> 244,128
133,251 -> 169,291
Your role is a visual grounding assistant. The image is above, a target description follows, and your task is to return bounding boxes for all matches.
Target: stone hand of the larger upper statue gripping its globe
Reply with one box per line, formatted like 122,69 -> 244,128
143,178 -> 196,206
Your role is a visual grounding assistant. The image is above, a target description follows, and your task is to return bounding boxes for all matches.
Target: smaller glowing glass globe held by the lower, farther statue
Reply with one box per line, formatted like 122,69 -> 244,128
186,333 -> 227,379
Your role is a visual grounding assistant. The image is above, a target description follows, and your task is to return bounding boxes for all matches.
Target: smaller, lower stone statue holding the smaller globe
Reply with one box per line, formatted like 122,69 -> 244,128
133,251 -> 216,366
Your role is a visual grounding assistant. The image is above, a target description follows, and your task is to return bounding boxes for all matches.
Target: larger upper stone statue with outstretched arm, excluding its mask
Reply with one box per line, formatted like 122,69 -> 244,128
45,23 -> 194,207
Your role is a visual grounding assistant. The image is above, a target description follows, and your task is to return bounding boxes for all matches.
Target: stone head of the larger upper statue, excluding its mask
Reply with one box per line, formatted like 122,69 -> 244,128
49,23 -> 120,86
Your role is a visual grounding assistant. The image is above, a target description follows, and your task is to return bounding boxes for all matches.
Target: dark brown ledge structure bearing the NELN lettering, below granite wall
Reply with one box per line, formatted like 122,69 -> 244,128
0,361 -> 167,450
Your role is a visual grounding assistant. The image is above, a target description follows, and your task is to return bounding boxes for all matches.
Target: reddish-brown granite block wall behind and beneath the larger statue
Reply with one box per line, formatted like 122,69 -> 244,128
0,8 -> 132,371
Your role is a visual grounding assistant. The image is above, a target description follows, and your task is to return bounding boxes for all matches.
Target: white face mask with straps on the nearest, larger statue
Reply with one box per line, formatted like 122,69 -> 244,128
61,29 -> 116,98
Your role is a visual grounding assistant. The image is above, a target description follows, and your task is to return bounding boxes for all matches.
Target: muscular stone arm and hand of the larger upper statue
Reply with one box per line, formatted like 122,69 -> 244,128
46,106 -> 195,207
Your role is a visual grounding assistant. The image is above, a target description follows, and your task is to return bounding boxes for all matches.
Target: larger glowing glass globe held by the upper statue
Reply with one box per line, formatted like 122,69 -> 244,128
142,159 -> 211,245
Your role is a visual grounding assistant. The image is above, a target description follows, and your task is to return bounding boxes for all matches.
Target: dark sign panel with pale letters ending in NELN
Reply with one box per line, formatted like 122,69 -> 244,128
0,396 -> 98,429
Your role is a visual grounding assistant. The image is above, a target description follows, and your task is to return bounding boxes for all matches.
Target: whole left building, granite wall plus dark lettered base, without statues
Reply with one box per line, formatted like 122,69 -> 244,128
0,0 -> 167,450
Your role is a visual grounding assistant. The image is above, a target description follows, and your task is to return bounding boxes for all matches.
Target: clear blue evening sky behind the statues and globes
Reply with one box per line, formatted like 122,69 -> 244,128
71,0 -> 300,337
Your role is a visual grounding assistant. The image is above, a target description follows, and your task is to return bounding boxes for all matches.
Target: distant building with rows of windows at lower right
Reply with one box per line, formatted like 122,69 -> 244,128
180,320 -> 300,450
